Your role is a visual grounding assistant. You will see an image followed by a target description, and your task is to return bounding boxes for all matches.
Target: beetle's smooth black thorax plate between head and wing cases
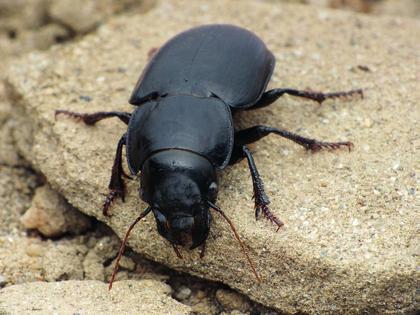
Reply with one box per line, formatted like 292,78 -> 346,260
126,95 -> 233,174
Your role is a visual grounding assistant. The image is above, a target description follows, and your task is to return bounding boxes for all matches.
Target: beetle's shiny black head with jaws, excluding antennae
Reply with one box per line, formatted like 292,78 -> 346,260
140,150 -> 217,249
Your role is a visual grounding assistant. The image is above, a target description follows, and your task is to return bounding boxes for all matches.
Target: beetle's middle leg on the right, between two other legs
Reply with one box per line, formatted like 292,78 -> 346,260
235,126 -> 353,152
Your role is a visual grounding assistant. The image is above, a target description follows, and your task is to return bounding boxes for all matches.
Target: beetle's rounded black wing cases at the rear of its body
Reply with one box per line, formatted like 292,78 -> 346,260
129,25 -> 275,108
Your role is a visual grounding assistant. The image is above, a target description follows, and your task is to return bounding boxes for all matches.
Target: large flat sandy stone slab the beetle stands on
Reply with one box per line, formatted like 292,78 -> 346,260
2,1 -> 420,314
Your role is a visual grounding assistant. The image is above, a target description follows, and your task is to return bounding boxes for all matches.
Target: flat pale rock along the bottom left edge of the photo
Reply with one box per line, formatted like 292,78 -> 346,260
0,280 -> 190,315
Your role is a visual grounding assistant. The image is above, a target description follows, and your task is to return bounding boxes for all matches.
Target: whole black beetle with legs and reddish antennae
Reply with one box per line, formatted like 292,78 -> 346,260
56,25 -> 363,287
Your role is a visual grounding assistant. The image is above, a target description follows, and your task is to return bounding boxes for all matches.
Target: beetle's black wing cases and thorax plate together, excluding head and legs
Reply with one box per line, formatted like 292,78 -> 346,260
126,25 -> 275,173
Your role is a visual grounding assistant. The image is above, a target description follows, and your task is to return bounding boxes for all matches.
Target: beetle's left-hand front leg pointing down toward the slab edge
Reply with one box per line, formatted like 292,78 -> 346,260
103,134 -> 126,216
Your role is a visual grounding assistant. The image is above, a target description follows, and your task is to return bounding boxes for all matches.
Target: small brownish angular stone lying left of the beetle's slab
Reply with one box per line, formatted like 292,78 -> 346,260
21,185 -> 91,237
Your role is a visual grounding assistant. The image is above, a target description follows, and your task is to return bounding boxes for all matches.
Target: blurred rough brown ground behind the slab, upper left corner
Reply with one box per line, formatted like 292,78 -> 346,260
0,0 -> 156,58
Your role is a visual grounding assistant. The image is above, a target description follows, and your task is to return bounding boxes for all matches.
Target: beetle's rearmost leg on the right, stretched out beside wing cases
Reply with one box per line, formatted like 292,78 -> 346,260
249,89 -> 363,109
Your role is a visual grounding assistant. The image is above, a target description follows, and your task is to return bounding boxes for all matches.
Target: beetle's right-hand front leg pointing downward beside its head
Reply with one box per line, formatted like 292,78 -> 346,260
242,145 -> 284,230
